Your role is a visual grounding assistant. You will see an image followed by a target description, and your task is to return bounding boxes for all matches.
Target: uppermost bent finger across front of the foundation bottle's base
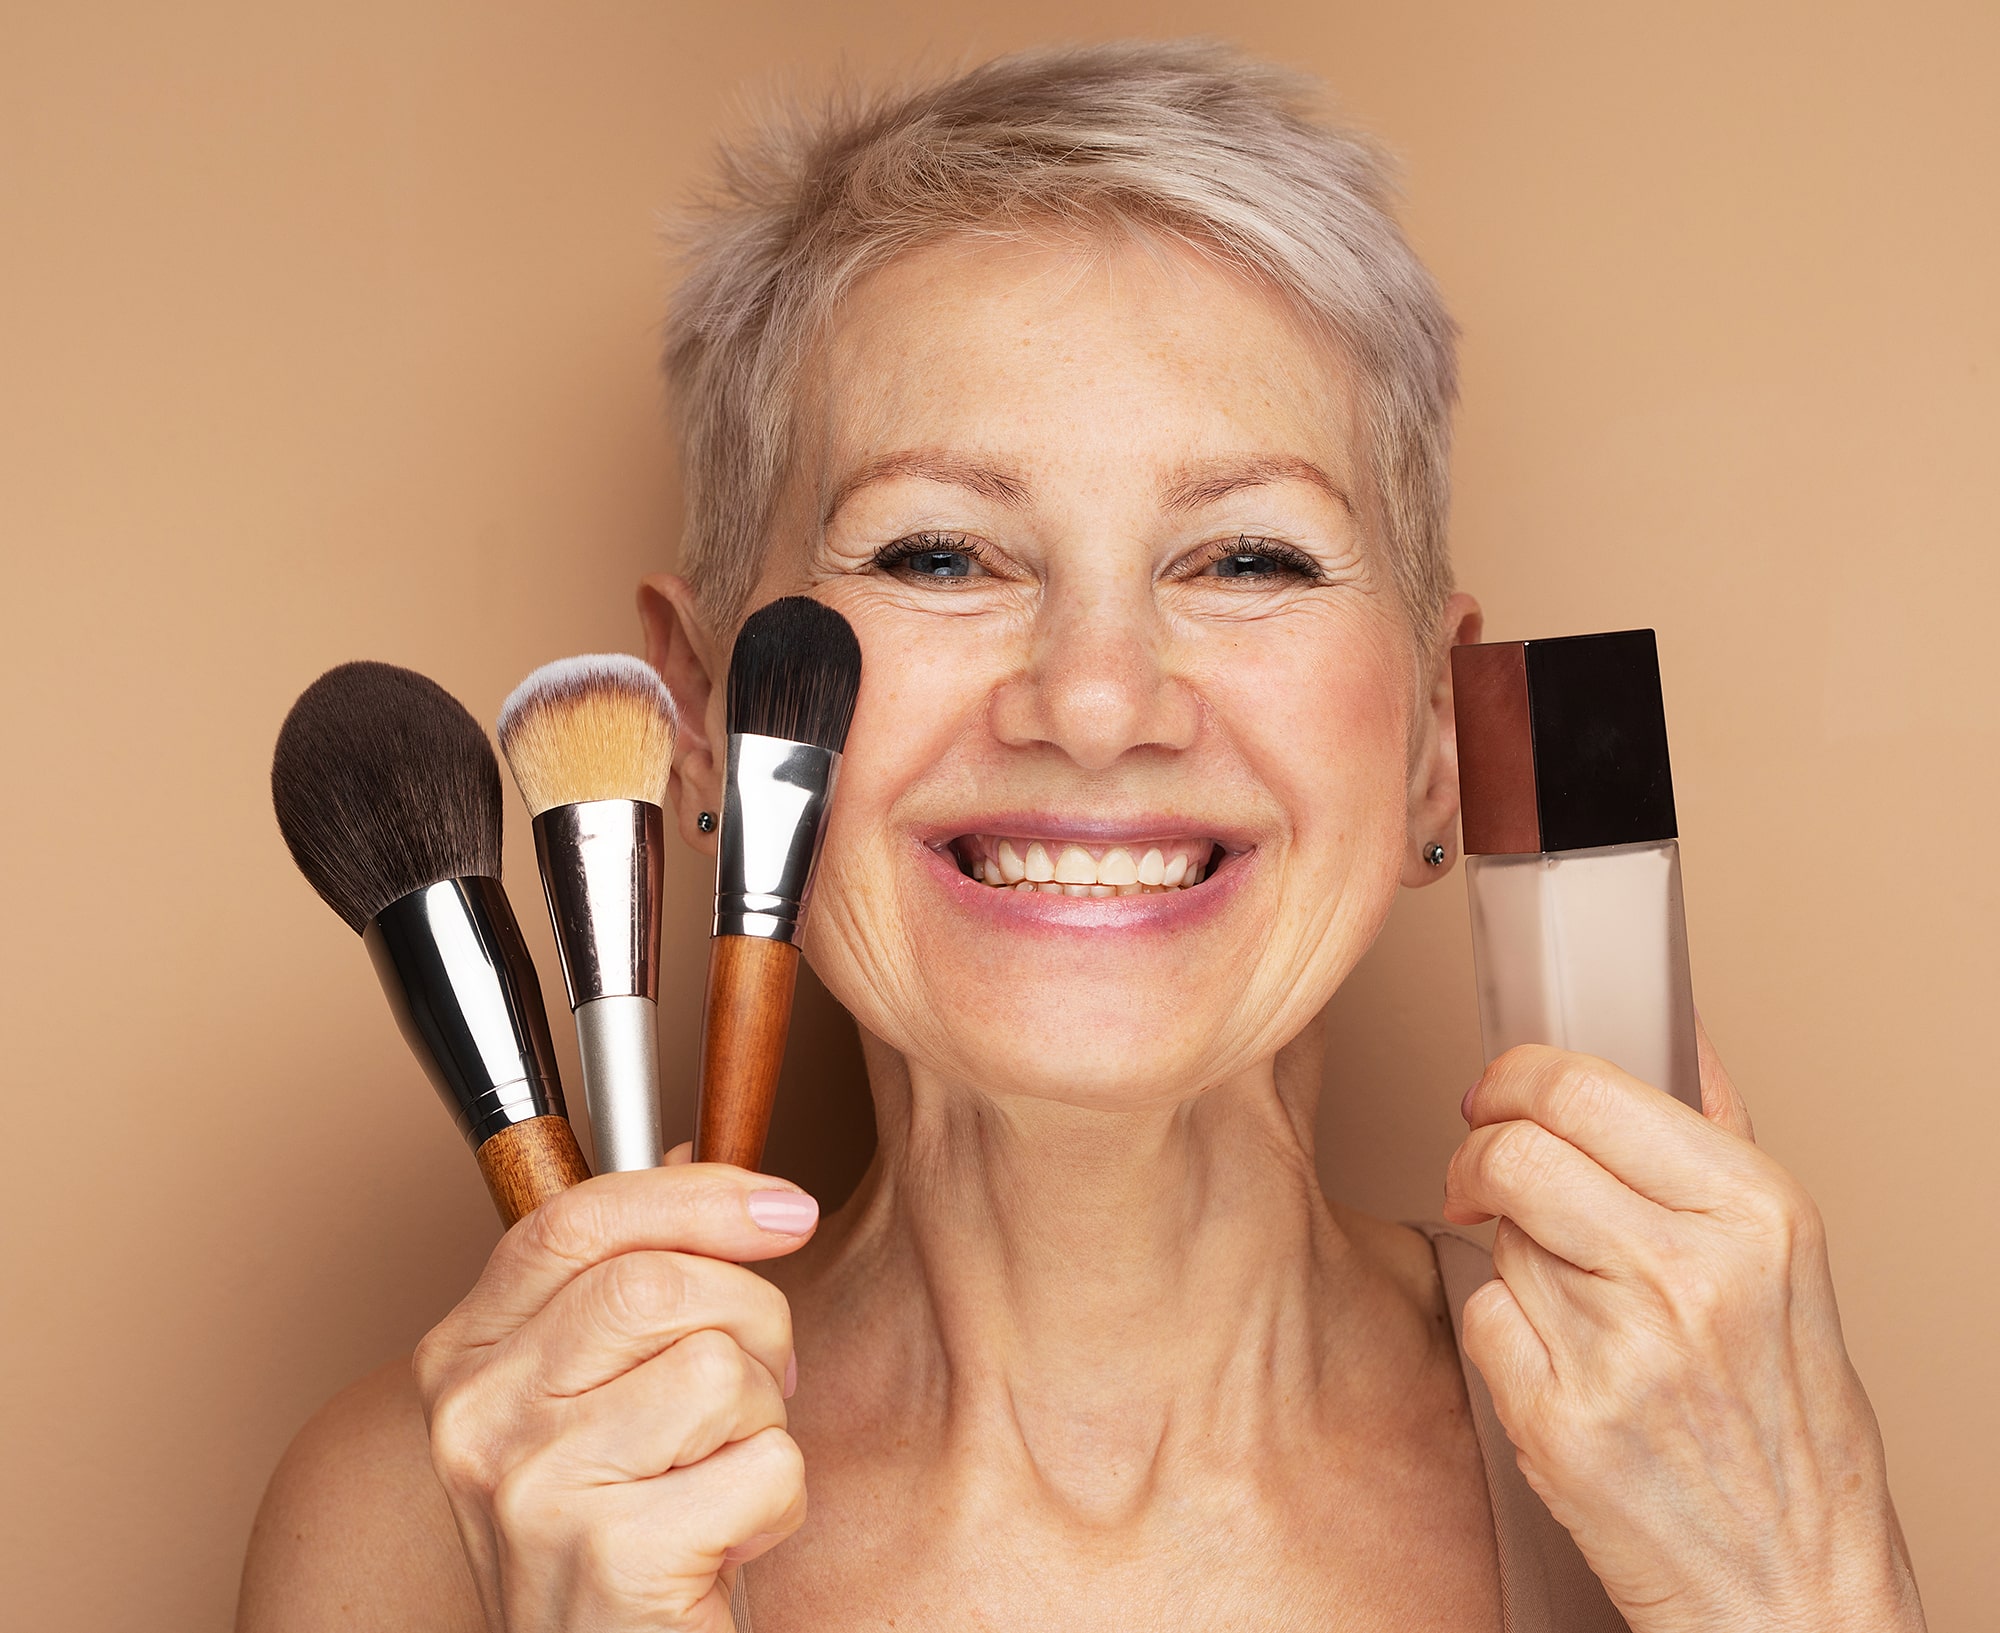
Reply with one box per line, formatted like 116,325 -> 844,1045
1464,1045 -> 1760,1211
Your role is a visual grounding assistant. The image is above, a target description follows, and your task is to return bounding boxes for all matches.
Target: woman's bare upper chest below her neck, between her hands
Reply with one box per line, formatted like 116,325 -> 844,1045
750,1405 -> 1500,1633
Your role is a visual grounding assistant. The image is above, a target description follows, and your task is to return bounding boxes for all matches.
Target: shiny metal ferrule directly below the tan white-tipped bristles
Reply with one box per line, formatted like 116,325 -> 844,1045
534,800 -> 666,1009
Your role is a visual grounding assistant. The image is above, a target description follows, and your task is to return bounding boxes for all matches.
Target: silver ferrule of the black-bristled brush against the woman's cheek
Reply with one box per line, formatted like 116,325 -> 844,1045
716,732 -> 840,941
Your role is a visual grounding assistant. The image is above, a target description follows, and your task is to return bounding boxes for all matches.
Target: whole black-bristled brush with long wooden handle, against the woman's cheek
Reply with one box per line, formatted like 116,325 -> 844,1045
694,596 -> 862,1169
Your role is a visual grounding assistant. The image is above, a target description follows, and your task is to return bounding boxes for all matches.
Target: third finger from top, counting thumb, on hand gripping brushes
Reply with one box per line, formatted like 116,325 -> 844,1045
522,1331 -> 786,1485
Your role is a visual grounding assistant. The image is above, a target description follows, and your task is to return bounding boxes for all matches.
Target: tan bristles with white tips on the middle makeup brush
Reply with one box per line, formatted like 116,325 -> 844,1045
500,652 -> 674,817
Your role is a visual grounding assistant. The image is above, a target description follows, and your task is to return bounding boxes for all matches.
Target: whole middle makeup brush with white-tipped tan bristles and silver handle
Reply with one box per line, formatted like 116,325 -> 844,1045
500,652 -> 674,1173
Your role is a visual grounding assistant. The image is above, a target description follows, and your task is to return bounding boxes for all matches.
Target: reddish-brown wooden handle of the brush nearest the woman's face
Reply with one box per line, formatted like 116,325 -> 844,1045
694,937 -> 798,1169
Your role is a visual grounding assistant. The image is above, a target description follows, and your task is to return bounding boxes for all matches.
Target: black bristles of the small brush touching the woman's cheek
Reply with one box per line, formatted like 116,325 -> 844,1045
730,596 -> 862,754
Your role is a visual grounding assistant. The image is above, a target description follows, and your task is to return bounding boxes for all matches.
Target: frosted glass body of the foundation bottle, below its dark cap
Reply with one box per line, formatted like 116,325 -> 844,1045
1466,839 -> 1702,1109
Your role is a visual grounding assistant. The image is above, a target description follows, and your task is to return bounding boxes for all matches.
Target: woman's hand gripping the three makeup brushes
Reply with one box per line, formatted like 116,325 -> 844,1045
416,1149 -> 820,1633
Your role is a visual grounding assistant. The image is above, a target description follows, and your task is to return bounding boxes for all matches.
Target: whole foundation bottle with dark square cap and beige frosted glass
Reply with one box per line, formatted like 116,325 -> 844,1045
1452,630 -> 1702,1109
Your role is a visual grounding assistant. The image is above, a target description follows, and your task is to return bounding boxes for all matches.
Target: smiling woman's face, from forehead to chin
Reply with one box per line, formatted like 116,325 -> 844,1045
736,242 -> 1450,1107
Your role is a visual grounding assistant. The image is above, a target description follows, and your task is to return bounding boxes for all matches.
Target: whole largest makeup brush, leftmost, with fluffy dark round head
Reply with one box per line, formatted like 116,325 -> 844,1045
270,662 -> 590,1225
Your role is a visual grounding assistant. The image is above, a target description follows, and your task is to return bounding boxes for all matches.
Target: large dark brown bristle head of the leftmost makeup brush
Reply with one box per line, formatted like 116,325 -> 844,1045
270,662 -> 502,931
